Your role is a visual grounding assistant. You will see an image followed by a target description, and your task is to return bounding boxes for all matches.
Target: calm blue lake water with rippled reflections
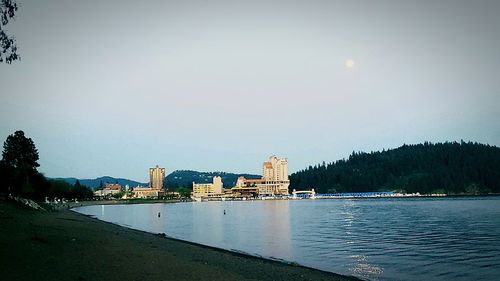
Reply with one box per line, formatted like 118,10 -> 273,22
76,197 -> 500,280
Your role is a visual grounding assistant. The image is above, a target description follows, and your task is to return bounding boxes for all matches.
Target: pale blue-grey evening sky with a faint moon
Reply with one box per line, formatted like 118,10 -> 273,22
0,0 -> 500,182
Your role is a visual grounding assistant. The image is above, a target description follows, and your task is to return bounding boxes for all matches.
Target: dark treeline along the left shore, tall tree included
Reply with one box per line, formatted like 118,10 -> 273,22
0,131 -> 93,199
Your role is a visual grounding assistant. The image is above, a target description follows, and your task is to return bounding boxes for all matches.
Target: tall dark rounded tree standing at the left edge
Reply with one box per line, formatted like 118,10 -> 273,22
0,131 -> 40,194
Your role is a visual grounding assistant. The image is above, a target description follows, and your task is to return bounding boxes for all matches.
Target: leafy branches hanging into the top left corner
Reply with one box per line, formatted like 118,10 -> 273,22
0,0 -> 21,64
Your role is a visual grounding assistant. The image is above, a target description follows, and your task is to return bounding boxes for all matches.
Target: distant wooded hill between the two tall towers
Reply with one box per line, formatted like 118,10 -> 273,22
165,170 -> 262,189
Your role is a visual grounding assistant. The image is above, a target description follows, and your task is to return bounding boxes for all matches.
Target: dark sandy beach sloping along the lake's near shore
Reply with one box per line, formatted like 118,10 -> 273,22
0,201 -> 358,280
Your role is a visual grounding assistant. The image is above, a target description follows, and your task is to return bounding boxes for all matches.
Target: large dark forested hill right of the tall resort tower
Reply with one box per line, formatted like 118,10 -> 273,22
290,142 -> 500,194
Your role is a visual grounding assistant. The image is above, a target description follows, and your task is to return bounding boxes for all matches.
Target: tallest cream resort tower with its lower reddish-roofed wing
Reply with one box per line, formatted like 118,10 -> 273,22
235,155 -> 290,196
